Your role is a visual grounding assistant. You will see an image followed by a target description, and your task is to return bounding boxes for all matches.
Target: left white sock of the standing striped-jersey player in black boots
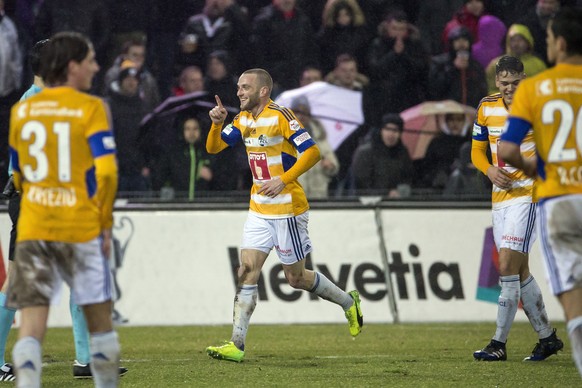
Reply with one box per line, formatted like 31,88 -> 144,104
493,275 -> 519,343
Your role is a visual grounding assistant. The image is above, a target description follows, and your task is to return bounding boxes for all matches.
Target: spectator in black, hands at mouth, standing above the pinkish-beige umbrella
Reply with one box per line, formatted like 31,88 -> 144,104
365,11 -> 429,126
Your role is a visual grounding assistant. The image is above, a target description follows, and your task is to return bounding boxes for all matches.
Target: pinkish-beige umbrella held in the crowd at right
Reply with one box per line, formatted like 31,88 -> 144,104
400,100 -> 477,160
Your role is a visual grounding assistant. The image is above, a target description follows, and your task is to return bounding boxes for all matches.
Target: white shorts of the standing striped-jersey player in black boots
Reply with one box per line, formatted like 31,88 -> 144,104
493,203 -> 537,253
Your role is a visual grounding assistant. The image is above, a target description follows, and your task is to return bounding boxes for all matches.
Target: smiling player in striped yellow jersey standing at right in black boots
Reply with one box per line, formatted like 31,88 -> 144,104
471,55 -> 564,361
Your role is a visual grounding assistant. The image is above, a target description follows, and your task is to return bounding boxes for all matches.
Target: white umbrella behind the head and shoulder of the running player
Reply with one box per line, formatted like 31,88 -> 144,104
275,81 -> 364,150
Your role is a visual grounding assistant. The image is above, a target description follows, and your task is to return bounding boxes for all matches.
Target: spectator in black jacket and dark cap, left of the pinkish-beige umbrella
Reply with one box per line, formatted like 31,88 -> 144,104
351,113 -> 414,198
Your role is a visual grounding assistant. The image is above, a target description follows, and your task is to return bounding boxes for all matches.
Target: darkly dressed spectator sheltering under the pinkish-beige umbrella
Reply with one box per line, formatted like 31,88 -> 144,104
420,113 -> 472,190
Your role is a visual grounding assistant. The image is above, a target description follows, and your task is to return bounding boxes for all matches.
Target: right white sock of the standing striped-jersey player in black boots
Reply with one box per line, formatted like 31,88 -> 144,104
521,275 -> 552,339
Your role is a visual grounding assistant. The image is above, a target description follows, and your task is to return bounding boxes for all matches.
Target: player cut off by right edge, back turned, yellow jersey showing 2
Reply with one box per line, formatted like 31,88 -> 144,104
499,8 -> 582,375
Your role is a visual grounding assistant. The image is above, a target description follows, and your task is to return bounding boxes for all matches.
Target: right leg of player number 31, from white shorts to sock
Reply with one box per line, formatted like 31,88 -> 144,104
74,238 -> 121,387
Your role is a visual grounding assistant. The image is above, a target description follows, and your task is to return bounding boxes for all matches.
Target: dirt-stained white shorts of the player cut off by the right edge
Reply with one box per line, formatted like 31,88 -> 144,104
538,195 -> 582,295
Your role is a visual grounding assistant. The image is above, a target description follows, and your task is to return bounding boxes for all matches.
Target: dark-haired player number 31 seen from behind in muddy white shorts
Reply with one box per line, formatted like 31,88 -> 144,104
7,32 -> 120,387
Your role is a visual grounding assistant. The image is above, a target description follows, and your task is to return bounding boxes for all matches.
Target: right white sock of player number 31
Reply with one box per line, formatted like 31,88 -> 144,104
91,331 -> 121,388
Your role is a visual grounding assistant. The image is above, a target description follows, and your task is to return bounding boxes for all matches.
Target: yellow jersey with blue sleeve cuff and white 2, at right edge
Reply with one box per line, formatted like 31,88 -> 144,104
502,63 -> 582,198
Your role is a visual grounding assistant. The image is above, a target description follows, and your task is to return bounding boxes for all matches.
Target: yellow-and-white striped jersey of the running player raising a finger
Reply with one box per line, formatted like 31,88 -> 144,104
221,101 -> 315,218
